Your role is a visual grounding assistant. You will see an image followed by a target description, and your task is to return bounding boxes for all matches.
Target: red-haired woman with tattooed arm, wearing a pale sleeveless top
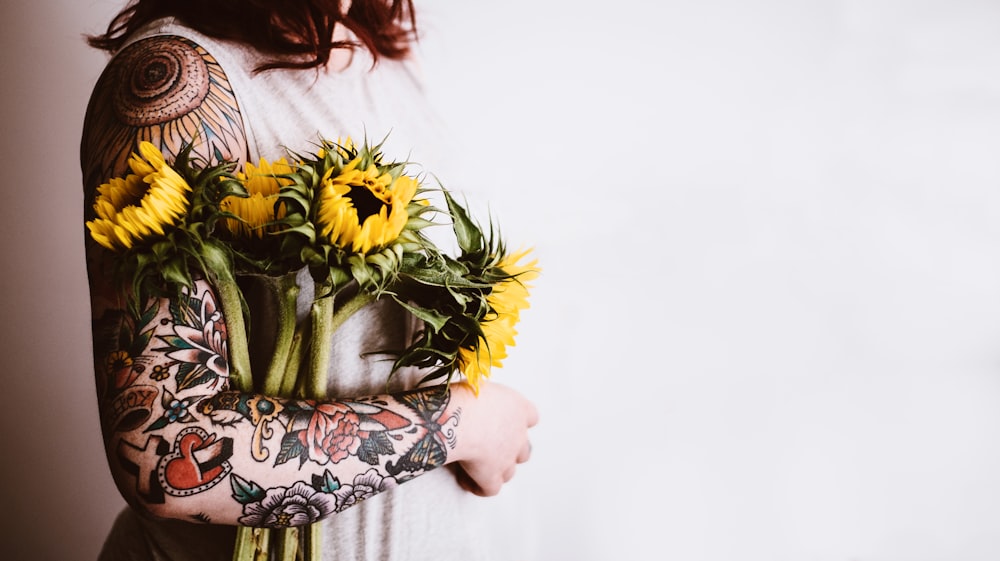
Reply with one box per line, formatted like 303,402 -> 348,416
81,0 -> 537,560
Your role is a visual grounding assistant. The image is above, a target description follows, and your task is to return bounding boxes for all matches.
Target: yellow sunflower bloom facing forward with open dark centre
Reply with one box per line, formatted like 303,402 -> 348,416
317,158 -> 418,254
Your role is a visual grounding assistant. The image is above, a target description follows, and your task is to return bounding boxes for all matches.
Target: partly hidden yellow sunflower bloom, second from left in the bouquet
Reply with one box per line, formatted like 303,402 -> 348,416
220,158 -> 292,239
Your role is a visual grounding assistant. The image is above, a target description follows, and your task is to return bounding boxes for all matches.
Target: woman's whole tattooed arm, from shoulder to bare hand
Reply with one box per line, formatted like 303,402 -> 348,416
81,37 -> 535,527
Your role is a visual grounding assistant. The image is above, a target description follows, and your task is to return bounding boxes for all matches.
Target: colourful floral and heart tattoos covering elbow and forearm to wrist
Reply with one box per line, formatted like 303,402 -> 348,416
94,281 -> 461,527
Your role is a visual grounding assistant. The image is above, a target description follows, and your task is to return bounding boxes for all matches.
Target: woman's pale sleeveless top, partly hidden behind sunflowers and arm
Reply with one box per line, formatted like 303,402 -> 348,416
100,20 -> 490,561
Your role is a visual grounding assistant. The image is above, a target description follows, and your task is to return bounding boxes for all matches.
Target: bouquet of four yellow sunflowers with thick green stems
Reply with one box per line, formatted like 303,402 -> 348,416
87,139 -> 537,560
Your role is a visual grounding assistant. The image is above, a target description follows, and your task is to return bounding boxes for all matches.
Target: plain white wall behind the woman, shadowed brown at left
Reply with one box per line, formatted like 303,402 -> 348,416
0,0 -> 1000,561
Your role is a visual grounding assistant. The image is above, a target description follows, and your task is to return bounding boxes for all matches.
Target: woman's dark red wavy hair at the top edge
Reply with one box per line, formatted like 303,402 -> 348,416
87,0 -> 416,70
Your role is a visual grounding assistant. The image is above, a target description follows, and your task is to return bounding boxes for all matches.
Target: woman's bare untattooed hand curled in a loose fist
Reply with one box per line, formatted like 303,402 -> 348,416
449,381 -> 538,497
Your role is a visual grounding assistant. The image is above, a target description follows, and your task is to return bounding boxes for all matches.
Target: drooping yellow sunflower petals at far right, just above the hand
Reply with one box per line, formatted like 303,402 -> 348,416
458,249 -> 538,391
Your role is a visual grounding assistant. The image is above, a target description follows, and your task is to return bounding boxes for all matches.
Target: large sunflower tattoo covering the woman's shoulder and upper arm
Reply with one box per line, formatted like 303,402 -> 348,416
80,36 -> 248,197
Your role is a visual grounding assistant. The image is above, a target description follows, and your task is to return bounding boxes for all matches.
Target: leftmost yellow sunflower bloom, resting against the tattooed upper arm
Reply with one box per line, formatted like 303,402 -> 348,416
87,142 -> 191,250
